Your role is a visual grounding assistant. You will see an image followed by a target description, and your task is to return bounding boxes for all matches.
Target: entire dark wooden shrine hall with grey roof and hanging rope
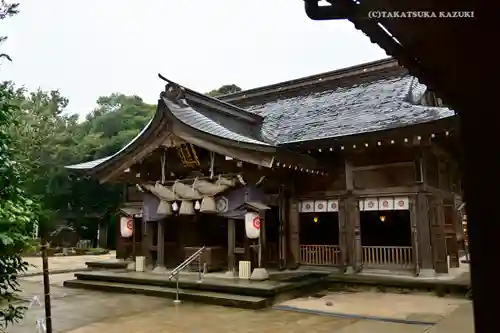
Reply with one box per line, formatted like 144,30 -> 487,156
67,59 -> 463,276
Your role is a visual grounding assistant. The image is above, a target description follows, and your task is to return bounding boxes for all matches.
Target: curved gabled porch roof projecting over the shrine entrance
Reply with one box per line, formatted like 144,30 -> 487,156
67,81 -> 318,179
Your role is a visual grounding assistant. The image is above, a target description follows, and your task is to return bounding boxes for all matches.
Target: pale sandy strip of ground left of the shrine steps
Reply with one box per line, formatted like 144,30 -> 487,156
23,251 -> 116,275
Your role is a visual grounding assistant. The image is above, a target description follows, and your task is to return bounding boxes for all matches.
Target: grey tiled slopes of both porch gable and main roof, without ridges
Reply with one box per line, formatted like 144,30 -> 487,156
67,69 -> 455,169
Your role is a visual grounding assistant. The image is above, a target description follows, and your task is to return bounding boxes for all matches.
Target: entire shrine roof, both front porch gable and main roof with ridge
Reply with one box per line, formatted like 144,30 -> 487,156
68,59 -> 454,175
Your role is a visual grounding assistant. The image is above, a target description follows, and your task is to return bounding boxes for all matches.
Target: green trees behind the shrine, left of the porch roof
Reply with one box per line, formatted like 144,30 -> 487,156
9,89 -> 155,238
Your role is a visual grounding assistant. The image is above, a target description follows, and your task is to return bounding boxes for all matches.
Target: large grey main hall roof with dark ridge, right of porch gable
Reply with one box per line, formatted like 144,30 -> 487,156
222,58 -> 455,145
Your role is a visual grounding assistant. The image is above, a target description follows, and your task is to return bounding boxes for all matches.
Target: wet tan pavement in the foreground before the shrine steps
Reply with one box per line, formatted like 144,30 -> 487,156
7,274 -> 470,333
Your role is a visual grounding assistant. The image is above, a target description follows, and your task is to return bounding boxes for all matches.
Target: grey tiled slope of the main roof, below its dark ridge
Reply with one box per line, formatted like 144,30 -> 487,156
244,74 -> 454,144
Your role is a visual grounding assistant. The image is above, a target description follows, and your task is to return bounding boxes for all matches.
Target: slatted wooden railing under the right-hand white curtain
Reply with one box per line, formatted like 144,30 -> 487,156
363,246 -> 413,268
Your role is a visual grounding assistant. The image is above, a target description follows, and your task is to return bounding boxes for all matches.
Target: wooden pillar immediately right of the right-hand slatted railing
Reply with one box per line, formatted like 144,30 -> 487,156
415,192 -> 434,273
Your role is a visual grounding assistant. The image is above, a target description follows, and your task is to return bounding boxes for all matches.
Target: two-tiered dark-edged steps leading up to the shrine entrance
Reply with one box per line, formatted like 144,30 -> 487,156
64,270 -> 325,309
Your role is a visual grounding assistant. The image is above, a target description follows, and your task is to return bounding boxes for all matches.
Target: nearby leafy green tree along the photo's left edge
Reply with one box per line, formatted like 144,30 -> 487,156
0,1 -> 36,331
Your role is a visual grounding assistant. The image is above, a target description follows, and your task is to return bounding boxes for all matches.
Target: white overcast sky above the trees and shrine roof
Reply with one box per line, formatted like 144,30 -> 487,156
0,0 -> 387,115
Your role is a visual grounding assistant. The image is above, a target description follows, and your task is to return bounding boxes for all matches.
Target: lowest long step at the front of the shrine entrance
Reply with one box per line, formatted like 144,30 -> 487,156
64,280 -> 271,310
